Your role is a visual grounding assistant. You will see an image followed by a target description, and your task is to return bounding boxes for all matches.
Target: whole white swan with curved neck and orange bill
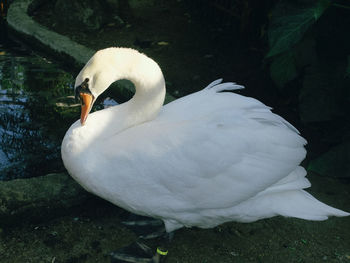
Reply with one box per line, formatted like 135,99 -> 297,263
61,47 -> 349,262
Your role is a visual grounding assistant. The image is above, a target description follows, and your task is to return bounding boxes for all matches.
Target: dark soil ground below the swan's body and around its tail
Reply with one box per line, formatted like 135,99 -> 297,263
0,175 -> 350,263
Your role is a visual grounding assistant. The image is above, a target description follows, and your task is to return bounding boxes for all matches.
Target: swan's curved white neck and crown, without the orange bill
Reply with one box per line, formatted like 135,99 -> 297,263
62,48 -> 165,155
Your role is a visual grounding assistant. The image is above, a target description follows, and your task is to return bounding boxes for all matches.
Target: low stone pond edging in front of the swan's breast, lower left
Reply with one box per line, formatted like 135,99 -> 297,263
0,174 -> 91,226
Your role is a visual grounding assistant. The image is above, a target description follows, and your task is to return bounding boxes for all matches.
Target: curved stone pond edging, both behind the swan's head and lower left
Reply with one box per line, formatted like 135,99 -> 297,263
0,0 -> 174,227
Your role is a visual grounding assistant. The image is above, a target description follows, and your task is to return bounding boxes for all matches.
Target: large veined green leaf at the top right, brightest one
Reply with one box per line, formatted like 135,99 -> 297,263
266,0 -> 331,57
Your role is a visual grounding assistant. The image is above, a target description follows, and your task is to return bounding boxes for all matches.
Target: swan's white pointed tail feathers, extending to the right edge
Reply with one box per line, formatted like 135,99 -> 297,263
233,166 -> 350,222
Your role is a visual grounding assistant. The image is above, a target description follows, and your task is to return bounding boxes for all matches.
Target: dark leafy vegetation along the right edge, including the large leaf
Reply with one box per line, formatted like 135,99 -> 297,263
266,0 -> 350,177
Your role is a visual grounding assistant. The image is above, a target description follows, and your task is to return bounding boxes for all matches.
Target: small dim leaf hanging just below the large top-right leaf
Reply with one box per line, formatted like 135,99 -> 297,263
270,52 -> 298,89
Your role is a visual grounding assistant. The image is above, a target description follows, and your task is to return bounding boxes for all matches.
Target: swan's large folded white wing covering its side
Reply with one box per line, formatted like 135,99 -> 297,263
99,81 -> 306,216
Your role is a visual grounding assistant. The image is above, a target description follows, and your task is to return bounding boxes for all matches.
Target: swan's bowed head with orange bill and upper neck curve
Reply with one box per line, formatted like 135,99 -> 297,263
75,48 -> 165,125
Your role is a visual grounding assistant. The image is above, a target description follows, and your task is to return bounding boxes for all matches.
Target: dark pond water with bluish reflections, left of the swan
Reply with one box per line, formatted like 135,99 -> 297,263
0,47 -> 79,180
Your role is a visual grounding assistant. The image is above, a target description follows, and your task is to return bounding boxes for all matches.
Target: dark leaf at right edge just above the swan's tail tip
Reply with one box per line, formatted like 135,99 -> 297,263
307,141 -> 350,177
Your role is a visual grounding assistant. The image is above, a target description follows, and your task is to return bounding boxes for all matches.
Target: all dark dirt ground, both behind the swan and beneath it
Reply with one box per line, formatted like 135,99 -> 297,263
0,1 -> 350,263
